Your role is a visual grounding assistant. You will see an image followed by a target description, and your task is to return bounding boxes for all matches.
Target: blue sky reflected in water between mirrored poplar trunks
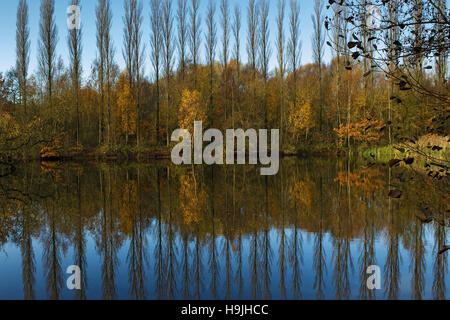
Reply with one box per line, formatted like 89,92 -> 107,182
0,227 -> 449,299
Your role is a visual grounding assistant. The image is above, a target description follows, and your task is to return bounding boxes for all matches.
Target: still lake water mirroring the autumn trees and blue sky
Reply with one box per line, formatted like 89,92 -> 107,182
0,159 -> 450,299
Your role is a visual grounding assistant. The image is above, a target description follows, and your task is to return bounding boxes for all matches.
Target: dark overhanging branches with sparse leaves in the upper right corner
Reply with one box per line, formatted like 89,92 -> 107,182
327,0 -> 450,101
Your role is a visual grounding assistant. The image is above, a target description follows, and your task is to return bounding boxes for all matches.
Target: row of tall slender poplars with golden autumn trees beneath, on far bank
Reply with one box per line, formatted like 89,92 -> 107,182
2,0 -> 449,158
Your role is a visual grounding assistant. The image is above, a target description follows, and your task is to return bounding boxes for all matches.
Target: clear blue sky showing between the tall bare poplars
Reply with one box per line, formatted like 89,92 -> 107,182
0,0 -> 329,77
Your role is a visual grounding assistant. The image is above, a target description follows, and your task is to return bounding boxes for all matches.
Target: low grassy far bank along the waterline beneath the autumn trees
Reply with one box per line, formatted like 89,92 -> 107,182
0,135 -> 450,163
